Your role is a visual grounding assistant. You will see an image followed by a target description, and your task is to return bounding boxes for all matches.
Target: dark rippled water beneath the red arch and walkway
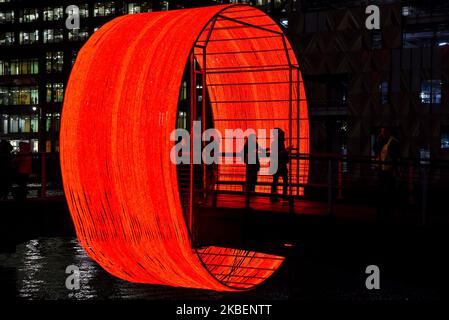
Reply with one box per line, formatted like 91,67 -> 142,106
0,237 -> 441,301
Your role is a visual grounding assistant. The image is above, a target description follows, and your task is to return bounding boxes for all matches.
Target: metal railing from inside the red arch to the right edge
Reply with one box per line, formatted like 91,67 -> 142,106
202,153 -> 449,224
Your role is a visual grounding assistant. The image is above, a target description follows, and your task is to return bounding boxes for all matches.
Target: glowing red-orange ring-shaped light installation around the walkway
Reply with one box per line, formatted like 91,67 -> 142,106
60,5 -> 309,291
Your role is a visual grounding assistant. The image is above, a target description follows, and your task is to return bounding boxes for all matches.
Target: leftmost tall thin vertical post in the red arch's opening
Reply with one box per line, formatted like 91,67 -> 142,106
187,49 -> 196,237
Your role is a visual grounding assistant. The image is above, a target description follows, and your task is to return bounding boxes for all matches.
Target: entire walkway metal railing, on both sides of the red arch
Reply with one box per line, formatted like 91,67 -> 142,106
4,152 -> 449,224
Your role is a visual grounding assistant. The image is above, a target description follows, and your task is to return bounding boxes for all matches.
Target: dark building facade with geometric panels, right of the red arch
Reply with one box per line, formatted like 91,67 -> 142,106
289,4 -> 449,159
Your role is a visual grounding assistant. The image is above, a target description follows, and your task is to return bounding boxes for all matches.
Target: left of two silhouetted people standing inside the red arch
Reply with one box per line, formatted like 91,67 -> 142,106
243,134 -> 260,193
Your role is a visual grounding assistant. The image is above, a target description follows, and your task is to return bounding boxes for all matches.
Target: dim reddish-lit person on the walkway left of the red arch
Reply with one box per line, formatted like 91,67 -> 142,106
14,142 -> 32,201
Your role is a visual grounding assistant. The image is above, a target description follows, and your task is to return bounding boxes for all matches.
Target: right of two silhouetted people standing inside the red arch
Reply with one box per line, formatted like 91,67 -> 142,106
270,128 -> 290,201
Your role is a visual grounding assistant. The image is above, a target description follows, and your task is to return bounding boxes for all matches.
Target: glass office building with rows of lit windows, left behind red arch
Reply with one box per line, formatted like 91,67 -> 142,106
0,0 -> 282,152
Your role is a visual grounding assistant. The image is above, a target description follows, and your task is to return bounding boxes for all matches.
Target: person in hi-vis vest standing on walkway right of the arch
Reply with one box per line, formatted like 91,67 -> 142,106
374,128 -> 400,222
